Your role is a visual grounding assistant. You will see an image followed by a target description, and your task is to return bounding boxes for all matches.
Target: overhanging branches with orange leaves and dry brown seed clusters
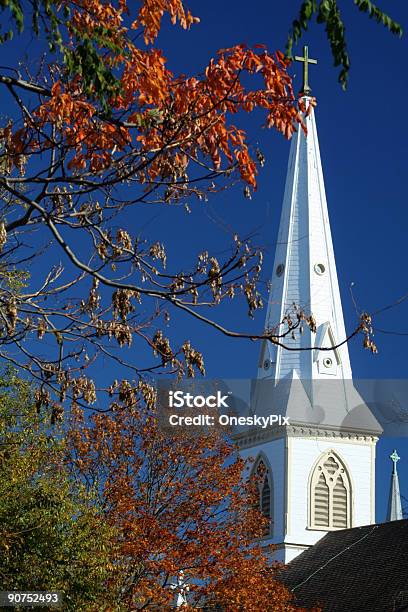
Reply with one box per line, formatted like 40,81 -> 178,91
0,0 -> 400,413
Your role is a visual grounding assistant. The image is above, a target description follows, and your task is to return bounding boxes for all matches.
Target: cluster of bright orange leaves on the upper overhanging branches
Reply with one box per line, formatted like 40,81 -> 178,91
4,0 -> 302,188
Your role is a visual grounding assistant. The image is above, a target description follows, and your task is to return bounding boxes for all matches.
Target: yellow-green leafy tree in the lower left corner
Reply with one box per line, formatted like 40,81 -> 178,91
0,371 -> 118,611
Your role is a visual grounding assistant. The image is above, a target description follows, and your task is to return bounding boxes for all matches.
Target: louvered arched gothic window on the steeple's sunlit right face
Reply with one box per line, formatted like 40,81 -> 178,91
309,451 -> 351,530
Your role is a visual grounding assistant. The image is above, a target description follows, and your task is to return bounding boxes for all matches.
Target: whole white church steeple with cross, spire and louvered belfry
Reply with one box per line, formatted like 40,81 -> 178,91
235,48 -> 382,563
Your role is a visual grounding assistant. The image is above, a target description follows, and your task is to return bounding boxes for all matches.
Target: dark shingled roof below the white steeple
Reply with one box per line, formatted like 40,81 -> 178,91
281,520 -> 408,612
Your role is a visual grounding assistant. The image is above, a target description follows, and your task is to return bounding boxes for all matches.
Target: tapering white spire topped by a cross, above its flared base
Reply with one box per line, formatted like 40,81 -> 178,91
258,83 -> 352,382
